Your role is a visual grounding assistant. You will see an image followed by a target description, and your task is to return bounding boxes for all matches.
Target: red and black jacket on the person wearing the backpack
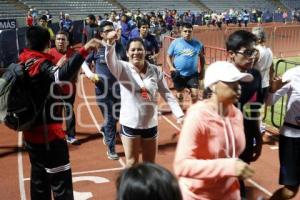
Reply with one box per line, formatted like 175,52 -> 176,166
19,48 -> 88,143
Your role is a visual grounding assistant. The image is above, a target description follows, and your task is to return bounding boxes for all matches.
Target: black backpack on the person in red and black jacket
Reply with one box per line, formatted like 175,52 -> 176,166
0,63 -> 41,131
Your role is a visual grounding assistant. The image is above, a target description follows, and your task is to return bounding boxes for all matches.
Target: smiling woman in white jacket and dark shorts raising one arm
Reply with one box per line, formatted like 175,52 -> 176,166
104,32 -> 184,167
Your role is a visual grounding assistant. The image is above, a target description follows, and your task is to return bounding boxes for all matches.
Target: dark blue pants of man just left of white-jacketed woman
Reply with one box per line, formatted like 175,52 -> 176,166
95,87 -> 120,151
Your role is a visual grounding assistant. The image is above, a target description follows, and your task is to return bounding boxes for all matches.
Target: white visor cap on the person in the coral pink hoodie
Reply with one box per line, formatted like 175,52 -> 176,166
204,61 -> 253,88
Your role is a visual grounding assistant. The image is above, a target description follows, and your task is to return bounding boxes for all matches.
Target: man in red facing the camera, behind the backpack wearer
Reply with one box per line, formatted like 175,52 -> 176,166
48,31 -> 79,144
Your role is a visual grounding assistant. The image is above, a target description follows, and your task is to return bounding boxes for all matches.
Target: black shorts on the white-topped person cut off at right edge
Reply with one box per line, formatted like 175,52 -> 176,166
279,135 -> 300,186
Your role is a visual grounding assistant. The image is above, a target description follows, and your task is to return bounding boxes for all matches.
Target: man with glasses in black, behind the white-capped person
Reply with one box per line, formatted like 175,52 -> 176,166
226,30 -> 263,197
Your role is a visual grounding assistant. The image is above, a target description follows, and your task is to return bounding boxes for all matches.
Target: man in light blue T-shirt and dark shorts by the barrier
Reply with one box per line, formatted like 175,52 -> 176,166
166,23 -> 205,107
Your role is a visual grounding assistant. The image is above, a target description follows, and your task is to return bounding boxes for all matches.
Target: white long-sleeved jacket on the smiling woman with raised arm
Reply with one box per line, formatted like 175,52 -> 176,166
105,45 -> 184,129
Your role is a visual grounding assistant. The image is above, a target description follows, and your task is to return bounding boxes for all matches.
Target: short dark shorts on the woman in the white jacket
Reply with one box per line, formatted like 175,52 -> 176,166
120,125 -> 158,139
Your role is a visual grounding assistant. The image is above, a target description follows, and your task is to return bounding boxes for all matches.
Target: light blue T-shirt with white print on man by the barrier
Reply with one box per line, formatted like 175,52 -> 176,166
168,38 -> 203,76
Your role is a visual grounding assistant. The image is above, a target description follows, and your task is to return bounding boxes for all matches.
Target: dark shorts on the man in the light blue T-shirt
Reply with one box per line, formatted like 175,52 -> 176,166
171,71 -> 199,91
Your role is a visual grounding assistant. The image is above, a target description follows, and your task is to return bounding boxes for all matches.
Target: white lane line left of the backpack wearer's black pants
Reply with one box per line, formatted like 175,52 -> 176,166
18,132 -> 26,200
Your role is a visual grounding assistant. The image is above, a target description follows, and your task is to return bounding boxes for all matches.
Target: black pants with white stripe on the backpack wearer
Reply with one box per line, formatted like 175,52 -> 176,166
25,140 -> 74,200
